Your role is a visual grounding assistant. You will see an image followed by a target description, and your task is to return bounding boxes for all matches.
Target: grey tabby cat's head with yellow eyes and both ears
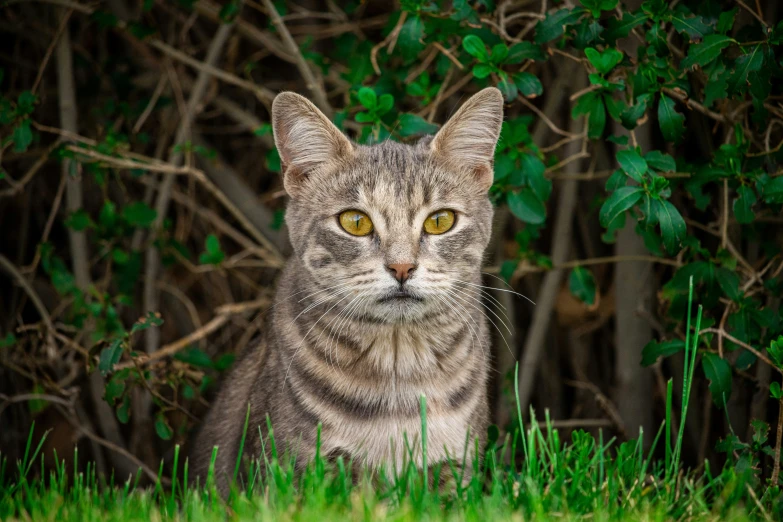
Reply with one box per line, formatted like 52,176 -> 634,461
272,88 -> 503,322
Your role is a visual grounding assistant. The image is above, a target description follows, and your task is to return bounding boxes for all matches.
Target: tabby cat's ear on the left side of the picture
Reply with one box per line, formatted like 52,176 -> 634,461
272,92 -> 354,197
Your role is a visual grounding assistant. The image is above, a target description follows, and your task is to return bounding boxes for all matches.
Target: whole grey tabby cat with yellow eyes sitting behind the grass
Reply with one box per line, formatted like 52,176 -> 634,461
191,88 -> 503,492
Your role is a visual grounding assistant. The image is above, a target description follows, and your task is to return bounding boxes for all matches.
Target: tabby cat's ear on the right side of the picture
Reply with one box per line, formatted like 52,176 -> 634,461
430,87 -> 503,190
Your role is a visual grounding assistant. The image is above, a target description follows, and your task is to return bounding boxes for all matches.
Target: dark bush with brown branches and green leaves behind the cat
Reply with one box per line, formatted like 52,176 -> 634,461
0,0 -> 783,481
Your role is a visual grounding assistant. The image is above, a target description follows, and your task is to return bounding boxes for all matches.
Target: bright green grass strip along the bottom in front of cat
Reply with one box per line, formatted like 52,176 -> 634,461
0,280 -> 781,522
